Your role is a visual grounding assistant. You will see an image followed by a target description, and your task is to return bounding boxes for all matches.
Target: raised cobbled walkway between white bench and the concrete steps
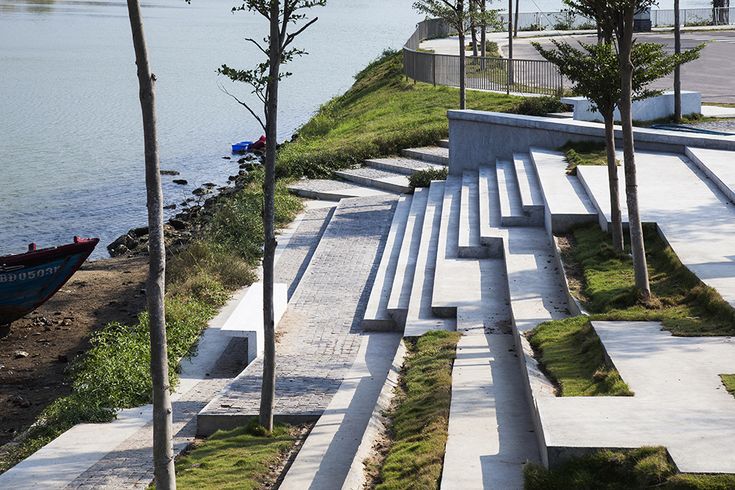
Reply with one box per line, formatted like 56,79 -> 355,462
199,197 -> 396,428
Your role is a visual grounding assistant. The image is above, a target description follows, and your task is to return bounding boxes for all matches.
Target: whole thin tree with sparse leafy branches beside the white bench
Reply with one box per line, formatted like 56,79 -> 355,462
219,0 -> 326,432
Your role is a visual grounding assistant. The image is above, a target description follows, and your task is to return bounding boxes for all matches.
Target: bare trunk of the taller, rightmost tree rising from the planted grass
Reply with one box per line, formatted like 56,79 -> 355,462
618,6 -> 651,302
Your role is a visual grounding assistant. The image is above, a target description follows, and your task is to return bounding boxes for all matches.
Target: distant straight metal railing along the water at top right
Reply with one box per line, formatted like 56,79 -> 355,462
498,7 -> 735,31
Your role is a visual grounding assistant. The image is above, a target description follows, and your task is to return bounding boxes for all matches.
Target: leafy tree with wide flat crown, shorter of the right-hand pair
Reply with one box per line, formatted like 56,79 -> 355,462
533,39 -> 702,252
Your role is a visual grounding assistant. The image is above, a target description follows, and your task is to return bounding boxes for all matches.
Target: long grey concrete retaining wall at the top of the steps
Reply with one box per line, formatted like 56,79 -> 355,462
447,110 -> 735,175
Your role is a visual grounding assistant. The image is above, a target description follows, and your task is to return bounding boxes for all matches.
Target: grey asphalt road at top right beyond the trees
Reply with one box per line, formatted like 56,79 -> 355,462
504,31 -> 735,103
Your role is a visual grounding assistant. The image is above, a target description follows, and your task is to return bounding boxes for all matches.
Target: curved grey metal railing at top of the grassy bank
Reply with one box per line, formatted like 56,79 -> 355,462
403,19 -> 564,95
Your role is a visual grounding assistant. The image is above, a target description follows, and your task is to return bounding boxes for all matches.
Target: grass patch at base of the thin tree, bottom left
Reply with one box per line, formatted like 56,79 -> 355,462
176,421 -> 300,490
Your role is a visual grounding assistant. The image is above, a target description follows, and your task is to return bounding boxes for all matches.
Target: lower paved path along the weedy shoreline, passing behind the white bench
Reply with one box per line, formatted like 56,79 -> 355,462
0,201 -> 333,489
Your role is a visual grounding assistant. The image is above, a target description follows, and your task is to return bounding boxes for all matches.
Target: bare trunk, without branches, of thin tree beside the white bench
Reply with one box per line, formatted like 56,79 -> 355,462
260,0 -> 281,432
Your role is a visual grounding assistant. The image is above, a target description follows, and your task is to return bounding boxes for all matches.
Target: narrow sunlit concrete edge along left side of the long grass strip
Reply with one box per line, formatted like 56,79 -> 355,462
342,340 -> 406,490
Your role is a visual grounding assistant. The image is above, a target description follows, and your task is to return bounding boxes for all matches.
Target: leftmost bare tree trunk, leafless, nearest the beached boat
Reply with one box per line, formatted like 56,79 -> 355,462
128,0 -> 176,490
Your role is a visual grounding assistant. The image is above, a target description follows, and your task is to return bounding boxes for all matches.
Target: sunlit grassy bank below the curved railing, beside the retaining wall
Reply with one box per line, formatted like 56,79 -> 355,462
278,51 -> 520,178
